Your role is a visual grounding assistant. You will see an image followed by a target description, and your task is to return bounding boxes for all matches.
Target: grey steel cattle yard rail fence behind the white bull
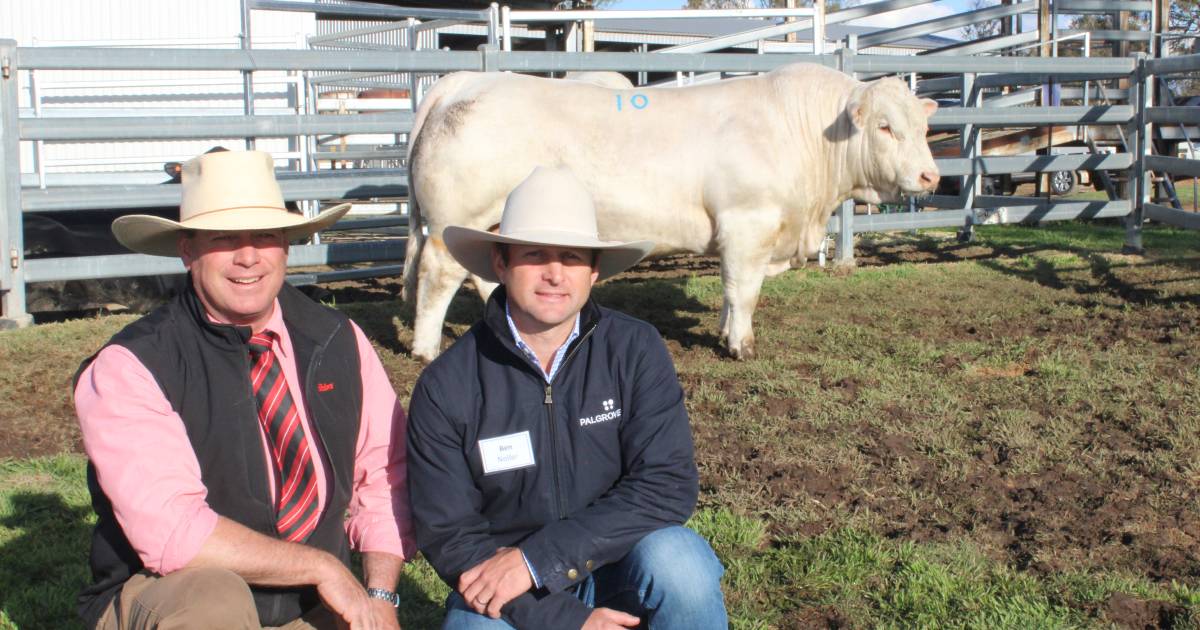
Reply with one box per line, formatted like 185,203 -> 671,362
0,40 -> 1200,326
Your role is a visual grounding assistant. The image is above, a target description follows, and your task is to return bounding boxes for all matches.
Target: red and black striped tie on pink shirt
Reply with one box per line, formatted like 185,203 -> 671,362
250,331 -> 320,542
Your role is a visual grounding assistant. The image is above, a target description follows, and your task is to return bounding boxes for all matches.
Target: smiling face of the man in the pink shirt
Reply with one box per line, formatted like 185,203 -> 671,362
179,229 -> 288,332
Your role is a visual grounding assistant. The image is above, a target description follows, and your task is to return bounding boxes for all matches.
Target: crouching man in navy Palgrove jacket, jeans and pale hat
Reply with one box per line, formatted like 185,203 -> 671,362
408,168 -> 726,630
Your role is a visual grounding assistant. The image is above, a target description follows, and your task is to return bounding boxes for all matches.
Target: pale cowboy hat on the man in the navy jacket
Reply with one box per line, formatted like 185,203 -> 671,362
442,167 -> 654,282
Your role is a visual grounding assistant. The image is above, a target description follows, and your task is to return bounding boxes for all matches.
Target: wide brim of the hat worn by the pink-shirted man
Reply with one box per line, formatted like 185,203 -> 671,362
113,203 -> 350,257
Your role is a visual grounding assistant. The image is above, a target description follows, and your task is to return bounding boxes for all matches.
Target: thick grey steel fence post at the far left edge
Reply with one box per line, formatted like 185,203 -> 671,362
0,40 -> 34,329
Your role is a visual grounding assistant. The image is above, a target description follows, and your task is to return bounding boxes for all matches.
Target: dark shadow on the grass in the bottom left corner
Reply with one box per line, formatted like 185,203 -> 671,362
0,492 -> 92,629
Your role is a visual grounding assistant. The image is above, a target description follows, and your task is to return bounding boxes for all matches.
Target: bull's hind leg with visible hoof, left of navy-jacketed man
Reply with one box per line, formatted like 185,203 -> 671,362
413,235 -> 467,362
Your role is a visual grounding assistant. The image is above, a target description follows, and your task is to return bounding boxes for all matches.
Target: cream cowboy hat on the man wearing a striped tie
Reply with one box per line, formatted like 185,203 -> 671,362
113,151 -> 350,256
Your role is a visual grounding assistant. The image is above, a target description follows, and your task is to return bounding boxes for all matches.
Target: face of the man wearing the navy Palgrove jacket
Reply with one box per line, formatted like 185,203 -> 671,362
492,245 -> 600,338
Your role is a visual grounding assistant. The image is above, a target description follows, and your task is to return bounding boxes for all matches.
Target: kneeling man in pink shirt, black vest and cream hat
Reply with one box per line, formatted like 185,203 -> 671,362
74,151 -> 414,629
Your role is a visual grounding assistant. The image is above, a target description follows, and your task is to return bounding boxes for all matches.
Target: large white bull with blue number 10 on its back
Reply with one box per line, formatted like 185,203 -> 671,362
404,64 -> 938,360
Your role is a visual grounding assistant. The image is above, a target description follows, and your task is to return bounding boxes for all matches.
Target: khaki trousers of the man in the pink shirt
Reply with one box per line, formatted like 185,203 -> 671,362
96,569 -> 336,630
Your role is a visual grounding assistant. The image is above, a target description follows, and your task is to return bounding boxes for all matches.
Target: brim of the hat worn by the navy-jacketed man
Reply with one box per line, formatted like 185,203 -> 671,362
442,226 -> 654,282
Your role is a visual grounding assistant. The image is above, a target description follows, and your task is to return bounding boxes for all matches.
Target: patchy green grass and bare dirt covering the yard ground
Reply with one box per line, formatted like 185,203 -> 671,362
0,222 -> 1200,629
